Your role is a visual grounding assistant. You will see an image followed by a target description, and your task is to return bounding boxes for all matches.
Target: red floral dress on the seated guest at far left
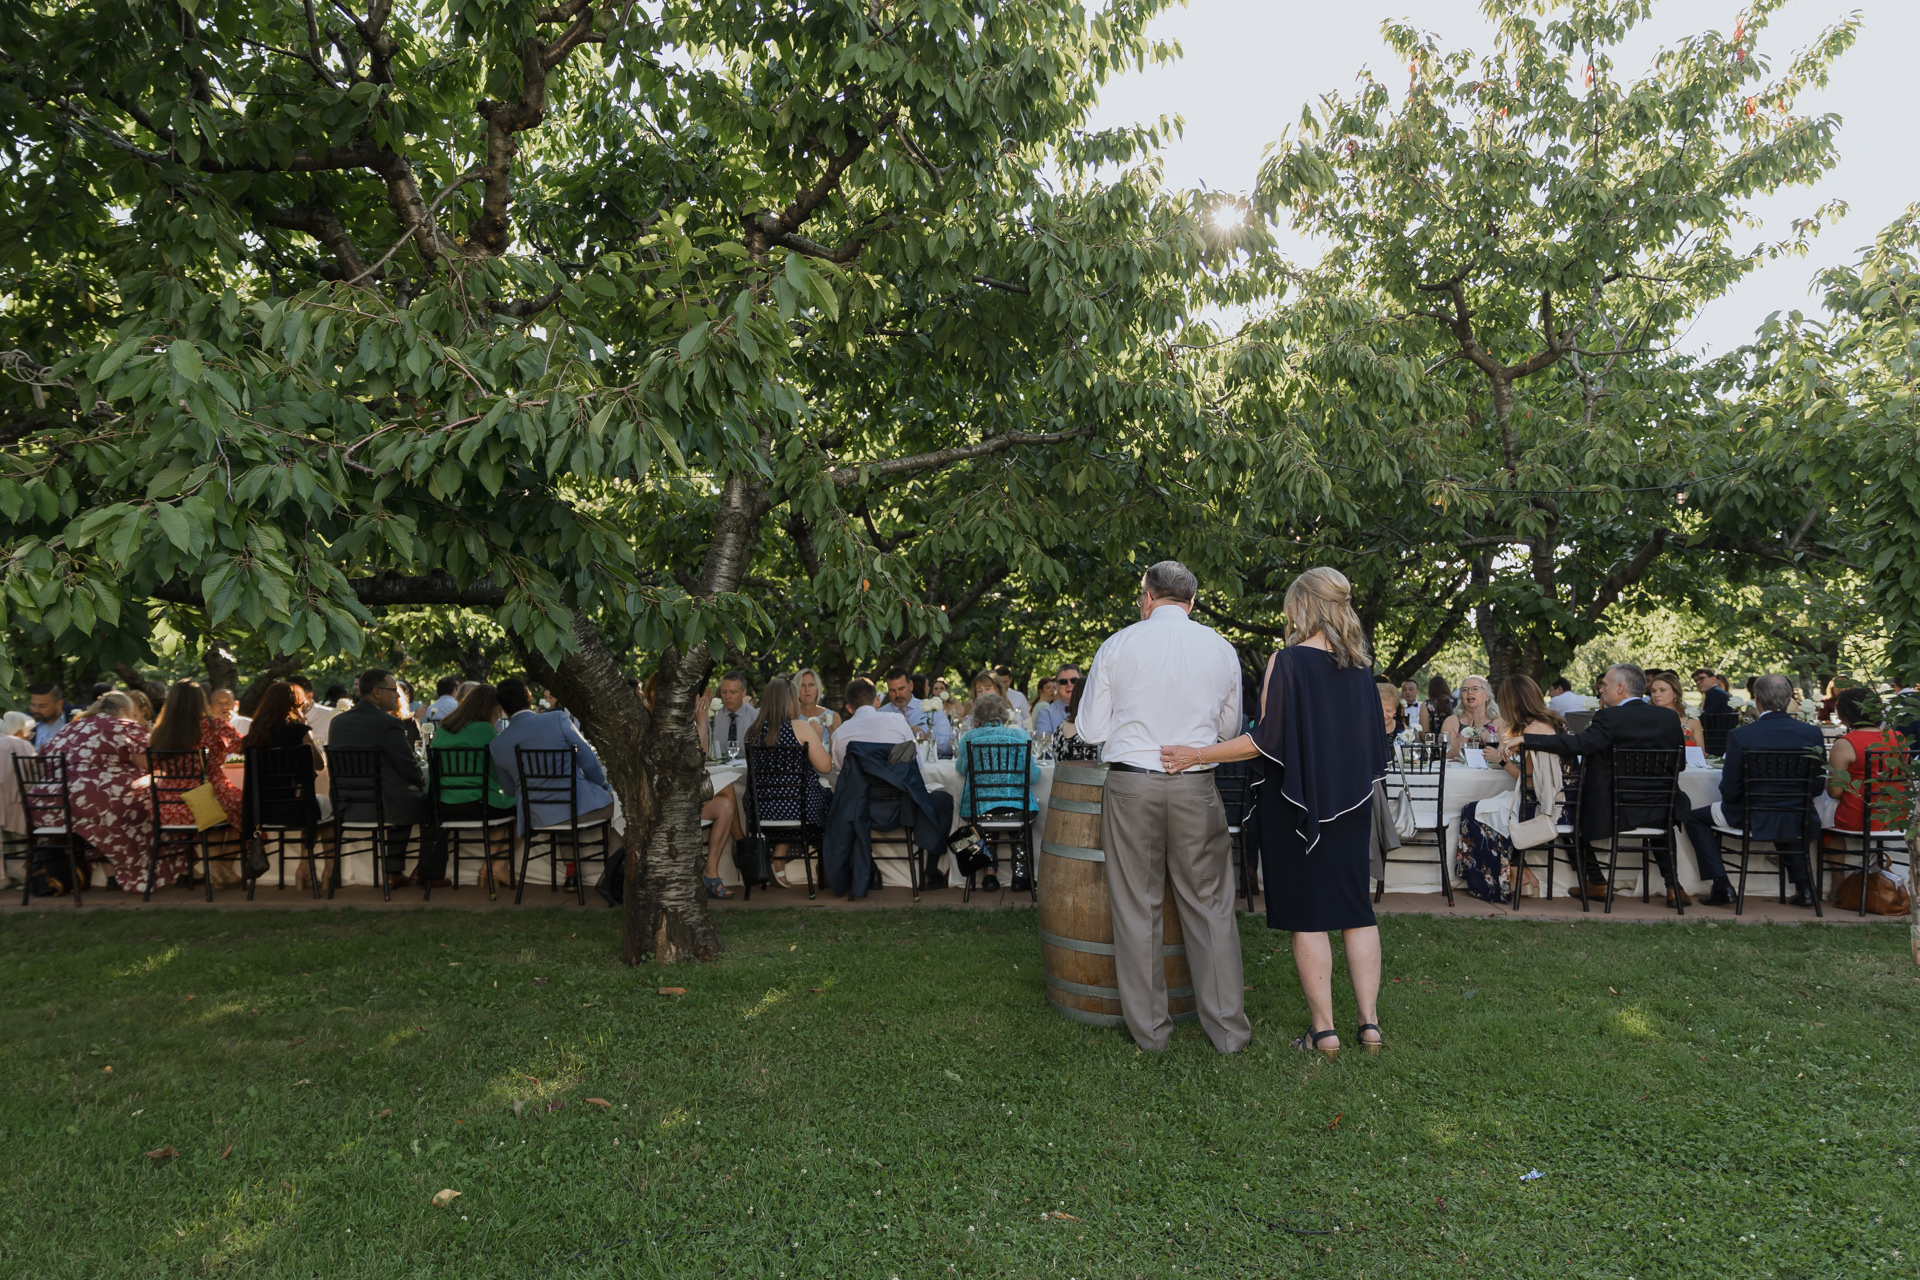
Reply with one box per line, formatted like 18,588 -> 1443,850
40,716 -> 165,892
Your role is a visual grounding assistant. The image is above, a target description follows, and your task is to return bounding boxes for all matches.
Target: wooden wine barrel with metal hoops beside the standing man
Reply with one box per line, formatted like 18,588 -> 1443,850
1039,764 -> 1200,1027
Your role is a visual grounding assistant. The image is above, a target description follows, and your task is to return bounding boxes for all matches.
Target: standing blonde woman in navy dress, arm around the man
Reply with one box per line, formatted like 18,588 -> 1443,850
1162,568 -> 1386,1057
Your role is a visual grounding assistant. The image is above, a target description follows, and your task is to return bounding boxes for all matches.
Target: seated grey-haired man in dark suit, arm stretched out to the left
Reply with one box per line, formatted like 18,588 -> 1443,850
1524,662 -> 1690,906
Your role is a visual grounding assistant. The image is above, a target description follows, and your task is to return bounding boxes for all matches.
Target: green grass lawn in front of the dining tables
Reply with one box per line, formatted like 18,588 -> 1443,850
0,908 -> 1920,1280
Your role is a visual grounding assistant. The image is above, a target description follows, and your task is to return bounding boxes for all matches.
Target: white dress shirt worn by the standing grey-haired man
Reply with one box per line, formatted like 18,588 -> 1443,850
1073,604 -> 1240,773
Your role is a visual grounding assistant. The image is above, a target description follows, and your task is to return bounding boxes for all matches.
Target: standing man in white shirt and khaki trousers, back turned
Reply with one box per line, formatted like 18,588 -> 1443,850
1077,560 -> 1254,1054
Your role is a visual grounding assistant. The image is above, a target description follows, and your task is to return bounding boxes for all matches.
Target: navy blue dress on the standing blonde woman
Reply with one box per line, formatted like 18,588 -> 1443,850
1252,647 -> 1386,933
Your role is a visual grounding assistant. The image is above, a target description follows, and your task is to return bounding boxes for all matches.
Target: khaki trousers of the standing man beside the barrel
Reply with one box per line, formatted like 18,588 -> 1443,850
1100,770 -> 1254,1054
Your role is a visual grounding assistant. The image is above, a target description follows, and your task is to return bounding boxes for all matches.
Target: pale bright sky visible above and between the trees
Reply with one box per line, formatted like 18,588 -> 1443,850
1094,0 -> 1920,355
